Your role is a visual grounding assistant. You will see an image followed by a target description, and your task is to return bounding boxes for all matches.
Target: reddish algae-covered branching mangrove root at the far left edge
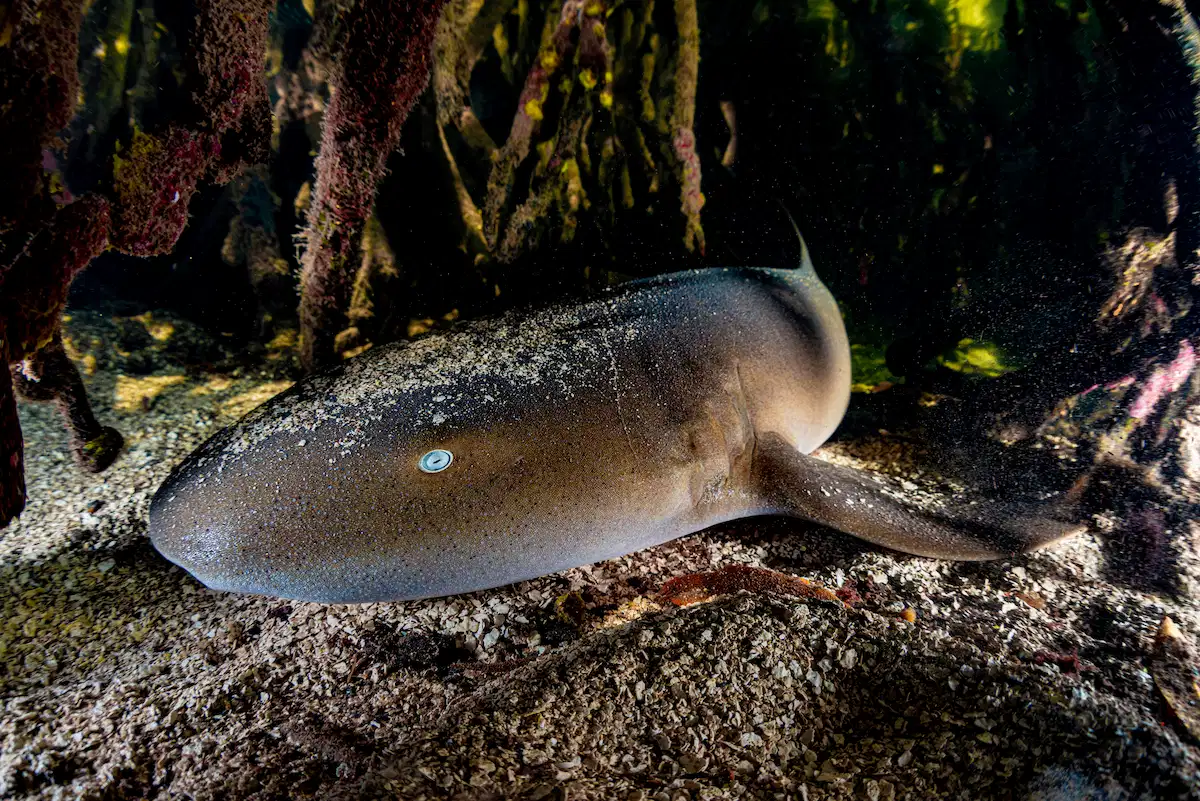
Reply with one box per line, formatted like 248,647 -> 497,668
0,0 -> 270,523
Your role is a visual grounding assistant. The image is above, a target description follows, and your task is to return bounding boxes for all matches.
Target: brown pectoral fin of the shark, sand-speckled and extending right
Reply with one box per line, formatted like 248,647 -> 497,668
755,435 -> 1087,561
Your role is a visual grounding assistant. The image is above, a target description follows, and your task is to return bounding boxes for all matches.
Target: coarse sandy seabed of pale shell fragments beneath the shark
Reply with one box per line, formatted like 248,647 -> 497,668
0,321 -> 1200,801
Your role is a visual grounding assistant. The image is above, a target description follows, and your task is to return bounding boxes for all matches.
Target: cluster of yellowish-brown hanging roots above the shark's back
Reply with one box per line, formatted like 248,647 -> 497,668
433,0 -> 704,264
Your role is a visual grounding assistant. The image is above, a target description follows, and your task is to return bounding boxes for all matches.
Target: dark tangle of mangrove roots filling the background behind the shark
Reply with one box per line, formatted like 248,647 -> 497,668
0,0 -> 1200,544
